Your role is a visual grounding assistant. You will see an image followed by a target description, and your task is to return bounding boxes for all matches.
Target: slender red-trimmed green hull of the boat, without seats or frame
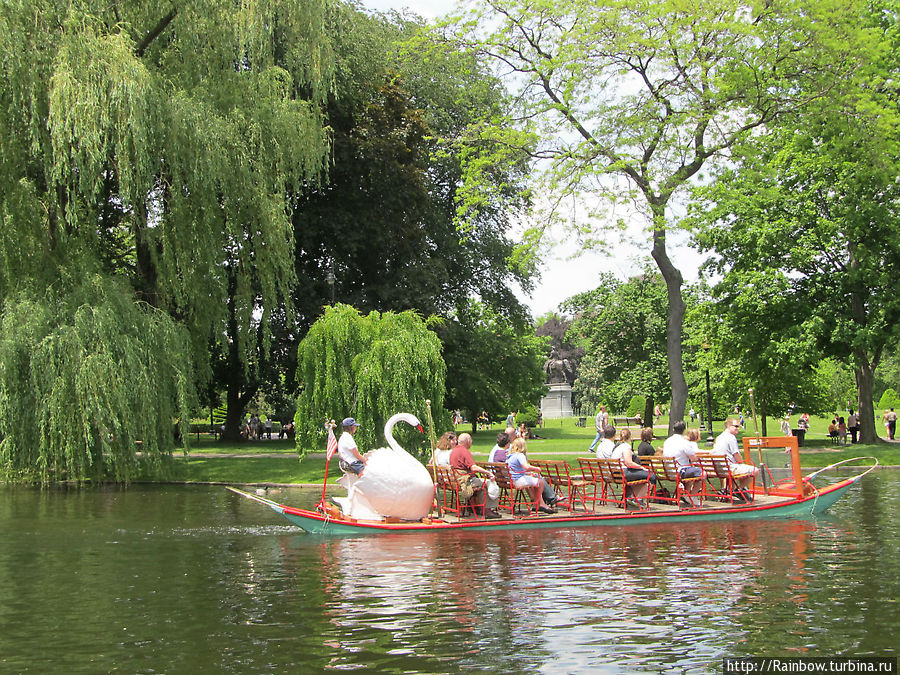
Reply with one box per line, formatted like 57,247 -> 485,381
229,476 -> 860,536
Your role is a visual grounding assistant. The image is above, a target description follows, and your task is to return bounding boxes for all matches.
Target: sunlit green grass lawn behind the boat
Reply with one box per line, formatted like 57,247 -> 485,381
153,418 -> 900,483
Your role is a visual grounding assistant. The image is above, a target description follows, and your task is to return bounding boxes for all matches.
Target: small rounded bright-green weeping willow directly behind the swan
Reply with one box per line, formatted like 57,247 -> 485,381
296,304 -> 446,457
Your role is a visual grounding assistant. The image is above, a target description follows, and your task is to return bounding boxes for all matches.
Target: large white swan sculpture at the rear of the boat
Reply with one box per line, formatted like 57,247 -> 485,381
334,413 -> 434,520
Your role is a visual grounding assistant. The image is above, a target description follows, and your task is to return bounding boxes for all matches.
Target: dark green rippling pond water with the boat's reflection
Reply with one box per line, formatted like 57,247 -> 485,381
0,470 -> 900,673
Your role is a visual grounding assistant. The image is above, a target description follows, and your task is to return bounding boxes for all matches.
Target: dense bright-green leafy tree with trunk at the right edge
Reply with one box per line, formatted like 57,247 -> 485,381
695,22 -> 900,442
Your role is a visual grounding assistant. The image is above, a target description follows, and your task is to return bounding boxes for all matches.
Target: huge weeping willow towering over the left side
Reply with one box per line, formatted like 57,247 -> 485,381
0,0 -> 333,475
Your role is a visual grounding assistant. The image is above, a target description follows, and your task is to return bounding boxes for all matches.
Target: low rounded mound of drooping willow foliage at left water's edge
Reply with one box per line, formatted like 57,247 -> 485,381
0,277 -> 193,483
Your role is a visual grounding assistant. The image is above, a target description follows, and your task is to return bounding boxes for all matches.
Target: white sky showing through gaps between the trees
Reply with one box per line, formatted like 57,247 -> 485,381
361,0 -> 702,318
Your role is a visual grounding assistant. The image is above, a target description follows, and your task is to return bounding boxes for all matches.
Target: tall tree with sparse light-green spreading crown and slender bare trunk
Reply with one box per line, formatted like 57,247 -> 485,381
452,0 -> 865,434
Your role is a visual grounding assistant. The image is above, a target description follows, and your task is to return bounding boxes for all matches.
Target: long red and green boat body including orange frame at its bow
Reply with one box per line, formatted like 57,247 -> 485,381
227,437 -> 878,535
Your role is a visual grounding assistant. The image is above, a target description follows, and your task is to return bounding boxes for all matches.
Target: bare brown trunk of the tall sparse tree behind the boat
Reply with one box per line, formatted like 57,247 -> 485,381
649,200 -> 688,435
